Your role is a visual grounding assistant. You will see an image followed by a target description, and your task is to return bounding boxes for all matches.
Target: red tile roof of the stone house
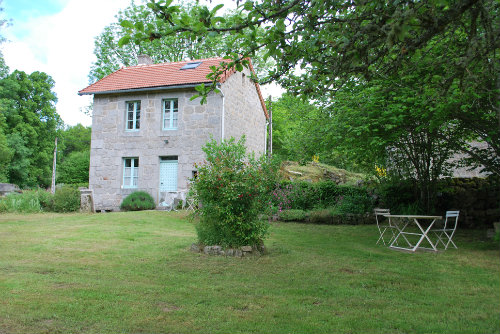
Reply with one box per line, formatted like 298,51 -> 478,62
78,57 -> 269,118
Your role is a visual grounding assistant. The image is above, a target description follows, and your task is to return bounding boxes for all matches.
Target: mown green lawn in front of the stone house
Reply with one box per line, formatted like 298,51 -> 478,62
0,211 -> 500,333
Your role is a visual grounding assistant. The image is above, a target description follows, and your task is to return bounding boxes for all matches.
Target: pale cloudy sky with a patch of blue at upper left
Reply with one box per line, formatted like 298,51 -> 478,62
0,0 -> 280,126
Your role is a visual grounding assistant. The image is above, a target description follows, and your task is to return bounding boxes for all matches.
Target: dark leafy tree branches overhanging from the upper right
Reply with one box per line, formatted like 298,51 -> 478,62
122,0 -> 500,174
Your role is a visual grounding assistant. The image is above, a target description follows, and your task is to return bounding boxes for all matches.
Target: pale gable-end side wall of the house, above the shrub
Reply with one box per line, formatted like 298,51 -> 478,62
221,69 -> 266,154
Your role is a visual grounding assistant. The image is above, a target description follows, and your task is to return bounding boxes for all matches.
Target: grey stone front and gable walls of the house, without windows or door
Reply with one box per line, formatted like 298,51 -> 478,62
89,66 -> 266,211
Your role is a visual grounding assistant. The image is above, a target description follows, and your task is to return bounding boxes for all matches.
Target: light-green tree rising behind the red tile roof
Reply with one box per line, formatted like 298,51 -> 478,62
89,2 -> 272,82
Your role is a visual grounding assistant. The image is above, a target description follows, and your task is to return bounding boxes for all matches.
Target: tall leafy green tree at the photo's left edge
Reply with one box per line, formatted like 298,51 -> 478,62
0,70 -> 62,187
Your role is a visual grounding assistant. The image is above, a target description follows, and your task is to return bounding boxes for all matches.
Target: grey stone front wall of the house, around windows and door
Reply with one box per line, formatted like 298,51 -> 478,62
89,89 -> 222,211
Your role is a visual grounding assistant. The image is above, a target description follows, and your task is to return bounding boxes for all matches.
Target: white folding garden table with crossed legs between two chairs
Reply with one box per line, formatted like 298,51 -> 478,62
384,215 -> 443,252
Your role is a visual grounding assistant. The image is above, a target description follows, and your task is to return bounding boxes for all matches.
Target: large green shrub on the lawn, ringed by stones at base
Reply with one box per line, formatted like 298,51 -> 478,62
191,137 -> 278,247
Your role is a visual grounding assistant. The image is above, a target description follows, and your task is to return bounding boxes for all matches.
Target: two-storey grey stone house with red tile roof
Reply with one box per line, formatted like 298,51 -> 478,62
79,56 -> 268,211
